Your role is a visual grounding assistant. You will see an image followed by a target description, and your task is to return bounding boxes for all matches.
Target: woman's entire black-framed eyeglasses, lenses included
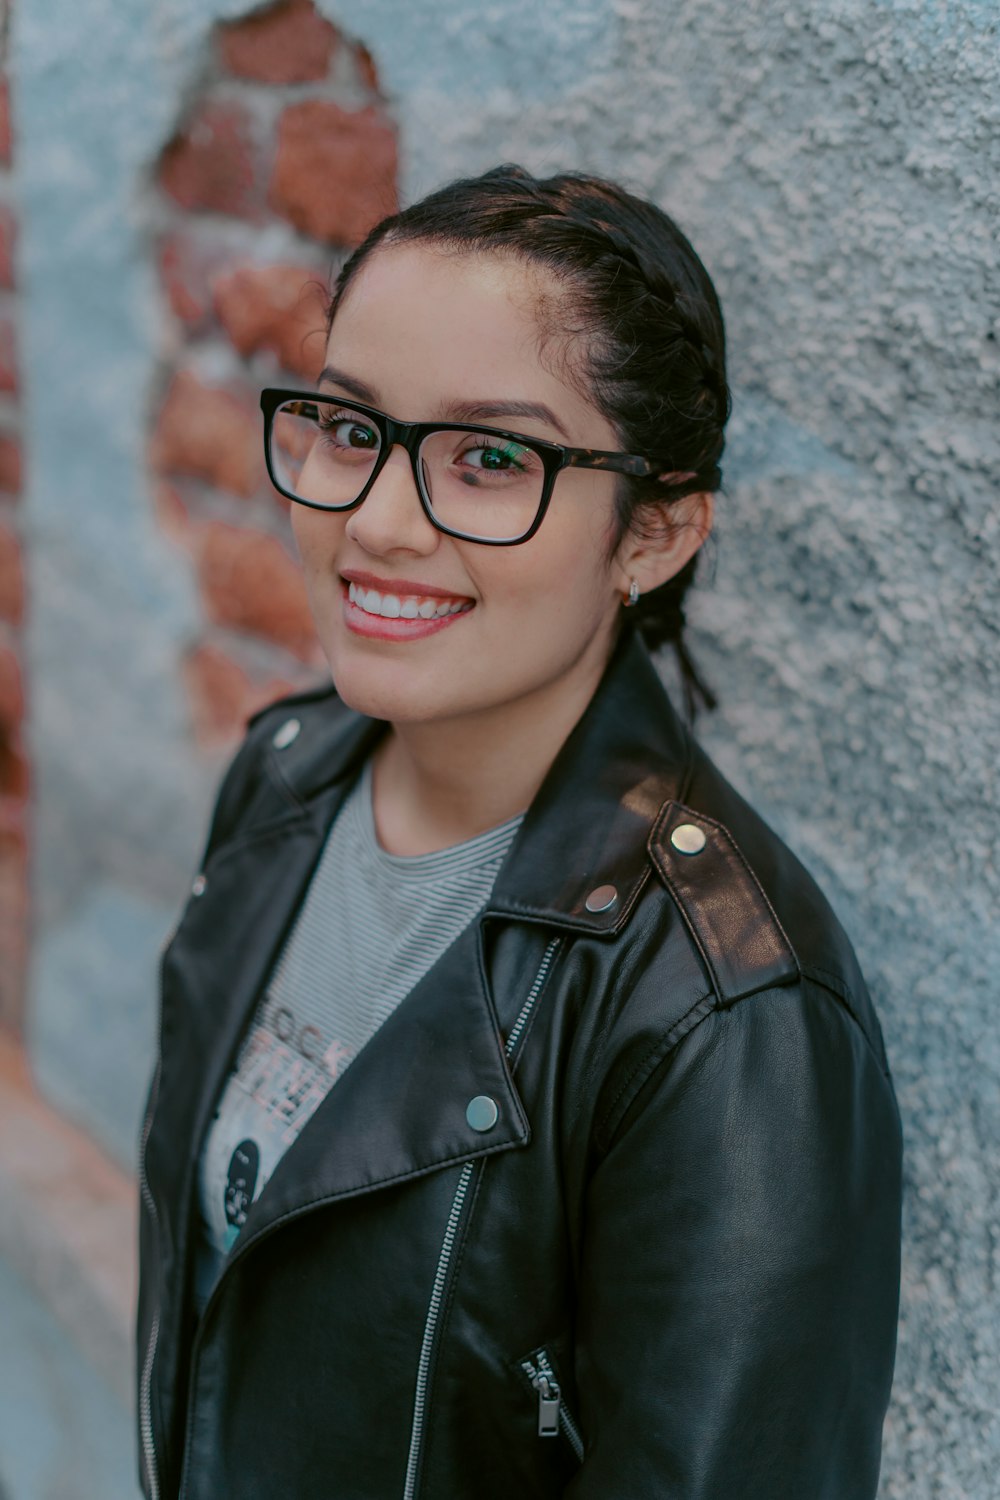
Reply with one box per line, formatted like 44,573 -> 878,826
261,389 -> 657,548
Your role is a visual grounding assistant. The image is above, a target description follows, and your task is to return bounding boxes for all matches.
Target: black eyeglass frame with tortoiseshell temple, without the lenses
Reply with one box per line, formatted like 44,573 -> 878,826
261,386 -> 660,548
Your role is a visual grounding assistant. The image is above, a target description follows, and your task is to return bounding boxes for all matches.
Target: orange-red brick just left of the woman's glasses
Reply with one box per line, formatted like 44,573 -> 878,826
150,371 -> 264,497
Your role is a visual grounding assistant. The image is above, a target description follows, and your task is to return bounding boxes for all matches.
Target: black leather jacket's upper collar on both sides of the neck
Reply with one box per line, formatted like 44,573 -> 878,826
270,630 -> 693,933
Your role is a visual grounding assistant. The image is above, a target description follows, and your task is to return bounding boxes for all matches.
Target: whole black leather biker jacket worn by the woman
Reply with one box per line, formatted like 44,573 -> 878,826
138,635 -> 900,1500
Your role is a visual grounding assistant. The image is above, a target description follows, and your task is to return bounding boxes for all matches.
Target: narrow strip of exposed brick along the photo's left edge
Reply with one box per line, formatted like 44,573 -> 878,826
0,0 -> 28,1034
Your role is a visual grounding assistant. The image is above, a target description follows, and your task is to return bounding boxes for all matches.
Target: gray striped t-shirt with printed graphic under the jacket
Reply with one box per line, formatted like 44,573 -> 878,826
196,762 -> 523,1305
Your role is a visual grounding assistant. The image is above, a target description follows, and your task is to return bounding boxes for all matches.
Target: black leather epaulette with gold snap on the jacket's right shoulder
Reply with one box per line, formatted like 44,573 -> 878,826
649,801 -> 801,1005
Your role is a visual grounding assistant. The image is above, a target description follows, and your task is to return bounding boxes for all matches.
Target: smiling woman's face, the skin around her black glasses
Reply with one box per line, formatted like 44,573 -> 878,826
292,246 -> 628,723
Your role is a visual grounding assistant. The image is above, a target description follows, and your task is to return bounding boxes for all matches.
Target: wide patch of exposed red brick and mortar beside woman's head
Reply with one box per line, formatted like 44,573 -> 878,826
148,0 -> 396,747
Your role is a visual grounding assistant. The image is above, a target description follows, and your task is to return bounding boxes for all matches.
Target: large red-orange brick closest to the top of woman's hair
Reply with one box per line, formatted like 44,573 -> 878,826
270,99 -> 399,245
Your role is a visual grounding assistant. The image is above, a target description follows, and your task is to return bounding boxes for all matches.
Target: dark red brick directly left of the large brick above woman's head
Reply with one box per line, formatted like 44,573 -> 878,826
159,104 -> 264,219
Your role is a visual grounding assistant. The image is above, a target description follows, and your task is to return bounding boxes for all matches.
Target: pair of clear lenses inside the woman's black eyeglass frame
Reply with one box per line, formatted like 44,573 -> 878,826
270,401 -> 546,540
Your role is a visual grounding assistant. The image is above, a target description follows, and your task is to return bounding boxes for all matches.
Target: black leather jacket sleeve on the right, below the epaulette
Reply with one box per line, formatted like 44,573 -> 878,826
567,980 -> 901,1500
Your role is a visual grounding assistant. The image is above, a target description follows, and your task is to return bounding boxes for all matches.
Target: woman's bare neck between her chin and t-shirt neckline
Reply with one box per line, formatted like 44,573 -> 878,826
372,633 -> 617,855
